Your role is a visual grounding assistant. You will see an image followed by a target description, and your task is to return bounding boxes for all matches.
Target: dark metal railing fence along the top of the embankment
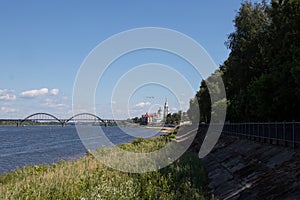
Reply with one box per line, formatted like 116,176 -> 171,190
199,122 -> 300,147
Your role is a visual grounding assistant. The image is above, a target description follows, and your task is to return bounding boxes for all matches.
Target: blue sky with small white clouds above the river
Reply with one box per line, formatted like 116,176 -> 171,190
0,0 -> 253,118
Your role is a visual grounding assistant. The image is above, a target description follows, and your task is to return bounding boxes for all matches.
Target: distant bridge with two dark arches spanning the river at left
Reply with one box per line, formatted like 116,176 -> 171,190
17,112 -> 115,126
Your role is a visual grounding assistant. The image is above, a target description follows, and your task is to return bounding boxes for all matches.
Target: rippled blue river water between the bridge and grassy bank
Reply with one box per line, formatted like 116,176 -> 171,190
0,126 -> 161,174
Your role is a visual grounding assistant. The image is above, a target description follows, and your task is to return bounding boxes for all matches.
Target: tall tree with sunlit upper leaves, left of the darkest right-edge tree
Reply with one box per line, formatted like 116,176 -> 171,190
221,2 -> 270,121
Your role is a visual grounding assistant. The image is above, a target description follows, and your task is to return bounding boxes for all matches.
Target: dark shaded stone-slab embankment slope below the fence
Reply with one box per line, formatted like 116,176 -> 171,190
204,136 -> 300,200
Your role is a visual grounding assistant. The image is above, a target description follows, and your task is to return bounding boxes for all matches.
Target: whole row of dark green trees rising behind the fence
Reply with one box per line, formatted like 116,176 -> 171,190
188,0 -> 300,122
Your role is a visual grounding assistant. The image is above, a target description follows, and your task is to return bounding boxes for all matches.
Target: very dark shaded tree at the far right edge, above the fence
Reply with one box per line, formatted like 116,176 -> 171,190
248,0 -> 300,121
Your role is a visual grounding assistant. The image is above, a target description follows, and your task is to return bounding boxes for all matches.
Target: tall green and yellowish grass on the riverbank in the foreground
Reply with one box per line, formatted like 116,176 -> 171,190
0,133 -> 206,200
